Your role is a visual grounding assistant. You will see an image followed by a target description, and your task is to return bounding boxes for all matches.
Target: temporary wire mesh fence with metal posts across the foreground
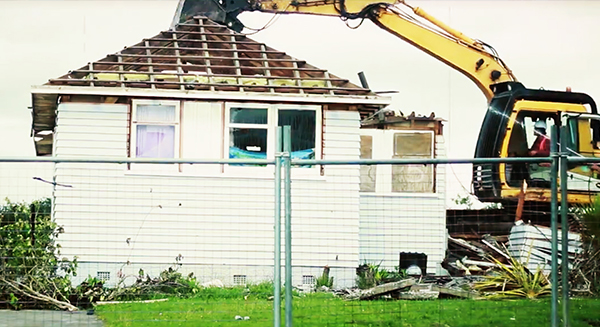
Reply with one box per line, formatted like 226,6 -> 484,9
0,124 -> 600,326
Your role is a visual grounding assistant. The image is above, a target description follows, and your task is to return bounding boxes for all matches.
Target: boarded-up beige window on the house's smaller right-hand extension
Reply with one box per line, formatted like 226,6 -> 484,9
360,129 -> 435,194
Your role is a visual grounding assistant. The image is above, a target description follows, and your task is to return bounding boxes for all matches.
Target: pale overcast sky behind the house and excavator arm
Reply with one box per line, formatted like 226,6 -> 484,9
0,0 -> 600,205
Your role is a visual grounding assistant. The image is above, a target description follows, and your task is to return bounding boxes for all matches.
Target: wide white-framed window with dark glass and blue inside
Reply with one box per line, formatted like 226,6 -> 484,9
225,104 -> 321,166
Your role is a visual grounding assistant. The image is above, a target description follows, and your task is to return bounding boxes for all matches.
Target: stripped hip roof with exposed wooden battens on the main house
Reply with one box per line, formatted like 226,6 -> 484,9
31,16 -> 390,155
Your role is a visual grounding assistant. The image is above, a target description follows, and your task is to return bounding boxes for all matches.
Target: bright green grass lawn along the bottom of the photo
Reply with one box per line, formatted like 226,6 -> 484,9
96,293 -> 600,327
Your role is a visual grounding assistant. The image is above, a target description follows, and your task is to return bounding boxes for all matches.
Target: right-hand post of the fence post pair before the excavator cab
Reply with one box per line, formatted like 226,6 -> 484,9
560,125 -> 570,327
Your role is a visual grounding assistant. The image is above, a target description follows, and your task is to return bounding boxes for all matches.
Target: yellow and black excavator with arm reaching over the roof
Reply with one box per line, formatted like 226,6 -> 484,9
173,0 -> 600,206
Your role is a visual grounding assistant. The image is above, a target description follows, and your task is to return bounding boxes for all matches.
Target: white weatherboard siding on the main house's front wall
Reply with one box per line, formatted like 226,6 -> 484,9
53,102 -> 360,283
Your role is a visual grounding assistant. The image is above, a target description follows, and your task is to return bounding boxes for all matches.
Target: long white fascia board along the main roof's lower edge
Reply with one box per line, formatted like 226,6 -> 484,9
31,85 -> 391,107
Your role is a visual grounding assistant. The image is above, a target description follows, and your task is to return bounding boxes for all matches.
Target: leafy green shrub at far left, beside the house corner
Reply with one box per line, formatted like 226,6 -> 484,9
0,198 -> 77,309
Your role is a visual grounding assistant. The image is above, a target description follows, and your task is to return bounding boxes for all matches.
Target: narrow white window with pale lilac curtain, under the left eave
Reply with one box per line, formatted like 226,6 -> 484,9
131,100 -> 179,159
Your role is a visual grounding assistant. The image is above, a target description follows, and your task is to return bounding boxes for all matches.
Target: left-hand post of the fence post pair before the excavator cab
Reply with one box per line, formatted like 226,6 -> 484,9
550,125 -> 558,327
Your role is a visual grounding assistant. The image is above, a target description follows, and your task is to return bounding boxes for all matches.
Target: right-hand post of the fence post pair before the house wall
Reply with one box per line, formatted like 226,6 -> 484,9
283,126 -> 292,327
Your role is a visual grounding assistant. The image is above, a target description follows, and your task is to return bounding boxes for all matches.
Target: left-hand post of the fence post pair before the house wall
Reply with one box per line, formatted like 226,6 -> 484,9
273,126 -> 283,327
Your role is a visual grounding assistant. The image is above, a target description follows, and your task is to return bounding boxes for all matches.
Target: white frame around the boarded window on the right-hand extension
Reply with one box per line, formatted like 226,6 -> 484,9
360,128 -> 438,197
